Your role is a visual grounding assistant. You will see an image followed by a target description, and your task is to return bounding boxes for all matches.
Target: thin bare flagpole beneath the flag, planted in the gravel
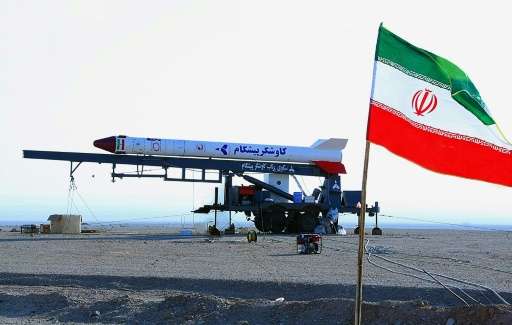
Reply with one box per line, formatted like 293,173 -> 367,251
354,141 -> 370,325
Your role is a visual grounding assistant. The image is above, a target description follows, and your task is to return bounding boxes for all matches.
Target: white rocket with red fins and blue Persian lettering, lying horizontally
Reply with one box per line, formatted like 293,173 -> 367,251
94,135 -> 348,173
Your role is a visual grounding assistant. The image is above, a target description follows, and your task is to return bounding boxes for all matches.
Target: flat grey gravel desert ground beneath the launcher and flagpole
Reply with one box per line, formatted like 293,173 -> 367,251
0,228 -> 512,324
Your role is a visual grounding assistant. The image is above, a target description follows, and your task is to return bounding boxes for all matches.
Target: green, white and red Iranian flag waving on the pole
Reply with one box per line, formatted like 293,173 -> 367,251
367,25 -> 512,186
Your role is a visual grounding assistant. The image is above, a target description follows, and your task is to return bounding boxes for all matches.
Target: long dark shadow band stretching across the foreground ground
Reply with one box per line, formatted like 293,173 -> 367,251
0,273 -> 512,306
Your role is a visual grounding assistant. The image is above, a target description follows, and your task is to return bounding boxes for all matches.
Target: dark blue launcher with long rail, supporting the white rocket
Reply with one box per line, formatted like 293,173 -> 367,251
23,150 -> 380,234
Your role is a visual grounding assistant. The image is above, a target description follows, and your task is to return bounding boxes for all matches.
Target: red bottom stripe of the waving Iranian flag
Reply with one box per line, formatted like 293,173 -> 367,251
367,104 -> 512,186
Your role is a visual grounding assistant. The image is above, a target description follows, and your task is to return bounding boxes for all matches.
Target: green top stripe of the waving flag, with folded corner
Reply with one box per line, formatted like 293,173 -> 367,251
375,25 -> 496,125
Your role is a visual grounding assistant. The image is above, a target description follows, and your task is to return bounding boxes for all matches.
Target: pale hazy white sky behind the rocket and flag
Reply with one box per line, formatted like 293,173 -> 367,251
0,0 -> 512,225
